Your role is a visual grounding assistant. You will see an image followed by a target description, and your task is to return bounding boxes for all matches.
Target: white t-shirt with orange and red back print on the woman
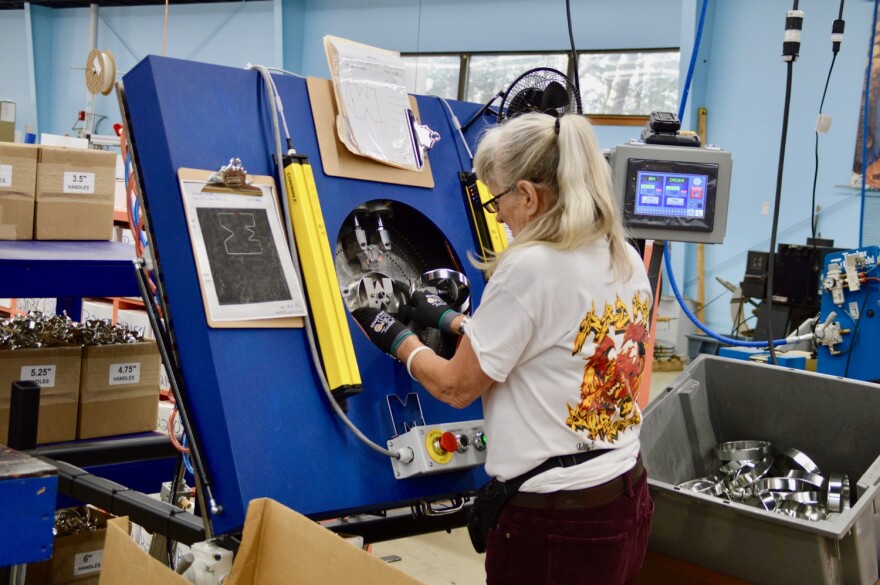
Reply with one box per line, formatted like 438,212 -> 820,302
465,241 -> 651,493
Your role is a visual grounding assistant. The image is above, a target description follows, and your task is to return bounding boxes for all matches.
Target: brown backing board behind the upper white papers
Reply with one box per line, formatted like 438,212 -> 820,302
306,77 -> 434,189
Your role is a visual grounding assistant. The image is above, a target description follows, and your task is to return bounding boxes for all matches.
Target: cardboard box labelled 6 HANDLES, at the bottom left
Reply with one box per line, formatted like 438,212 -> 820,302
25,507 -> 111,585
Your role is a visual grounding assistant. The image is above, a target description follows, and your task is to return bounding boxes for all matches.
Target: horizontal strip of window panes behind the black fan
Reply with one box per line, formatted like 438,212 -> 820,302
402,49 -> 680,125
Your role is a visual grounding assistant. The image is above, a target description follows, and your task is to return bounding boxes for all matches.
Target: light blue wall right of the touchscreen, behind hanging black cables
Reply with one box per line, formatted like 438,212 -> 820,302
688,0 -> 873,329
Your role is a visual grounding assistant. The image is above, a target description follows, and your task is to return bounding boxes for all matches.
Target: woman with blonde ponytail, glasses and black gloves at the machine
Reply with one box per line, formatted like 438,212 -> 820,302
354,113 -> 653,585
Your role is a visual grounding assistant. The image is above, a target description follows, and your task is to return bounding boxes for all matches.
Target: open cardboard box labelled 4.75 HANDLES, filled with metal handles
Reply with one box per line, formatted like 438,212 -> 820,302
76,342 -> 159,439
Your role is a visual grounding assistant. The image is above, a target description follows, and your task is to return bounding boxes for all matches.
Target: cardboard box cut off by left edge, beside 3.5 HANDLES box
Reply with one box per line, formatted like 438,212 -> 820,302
0,142 -> 40,240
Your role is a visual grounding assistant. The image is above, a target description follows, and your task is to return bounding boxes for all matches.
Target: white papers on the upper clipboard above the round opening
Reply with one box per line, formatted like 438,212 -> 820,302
324,35 -> 424,171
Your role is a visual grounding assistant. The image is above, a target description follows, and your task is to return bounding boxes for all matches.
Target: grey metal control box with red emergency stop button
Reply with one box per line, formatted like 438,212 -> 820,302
388,420 -> 486,479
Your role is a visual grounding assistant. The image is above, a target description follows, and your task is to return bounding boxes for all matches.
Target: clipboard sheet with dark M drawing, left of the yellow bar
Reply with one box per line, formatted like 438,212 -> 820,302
178,169 -> 306,327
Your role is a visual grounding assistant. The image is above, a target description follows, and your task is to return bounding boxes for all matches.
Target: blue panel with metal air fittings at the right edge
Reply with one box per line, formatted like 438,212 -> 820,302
816,246 -> 880,382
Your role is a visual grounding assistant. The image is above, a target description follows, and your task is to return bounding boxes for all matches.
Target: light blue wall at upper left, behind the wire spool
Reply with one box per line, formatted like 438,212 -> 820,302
9,1 -> 281,139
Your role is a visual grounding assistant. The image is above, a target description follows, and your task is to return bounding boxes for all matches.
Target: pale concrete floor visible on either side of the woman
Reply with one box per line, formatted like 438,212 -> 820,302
373,371 -> 681,585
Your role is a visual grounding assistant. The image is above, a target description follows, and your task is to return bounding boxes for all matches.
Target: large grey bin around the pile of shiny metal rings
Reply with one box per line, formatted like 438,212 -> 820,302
641,355 -> 880,585
